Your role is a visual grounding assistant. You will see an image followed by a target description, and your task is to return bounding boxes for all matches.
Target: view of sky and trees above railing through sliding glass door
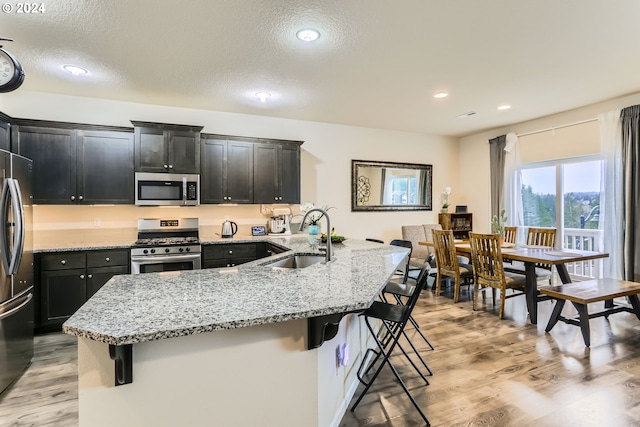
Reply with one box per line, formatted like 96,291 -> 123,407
522,160 -> 602,229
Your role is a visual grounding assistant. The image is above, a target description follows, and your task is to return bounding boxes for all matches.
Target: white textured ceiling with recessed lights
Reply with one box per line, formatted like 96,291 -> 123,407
0,0 -> 640,136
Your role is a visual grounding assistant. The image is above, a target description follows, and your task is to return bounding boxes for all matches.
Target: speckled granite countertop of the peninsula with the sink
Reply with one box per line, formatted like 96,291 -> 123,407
62,235 -> 409,345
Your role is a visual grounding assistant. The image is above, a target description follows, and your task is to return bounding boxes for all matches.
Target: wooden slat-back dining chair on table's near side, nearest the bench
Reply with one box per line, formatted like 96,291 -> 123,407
469,233 -> 526,319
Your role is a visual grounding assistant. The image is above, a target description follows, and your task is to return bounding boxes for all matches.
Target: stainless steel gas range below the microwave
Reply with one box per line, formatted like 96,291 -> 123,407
131,218 -> 202,274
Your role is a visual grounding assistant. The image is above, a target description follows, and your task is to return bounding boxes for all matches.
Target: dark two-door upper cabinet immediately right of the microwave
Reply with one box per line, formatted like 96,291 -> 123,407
200,135 -> 253,203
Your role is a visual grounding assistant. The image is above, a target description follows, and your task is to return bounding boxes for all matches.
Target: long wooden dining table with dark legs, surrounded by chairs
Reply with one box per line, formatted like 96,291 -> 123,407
419,241 -> 609,325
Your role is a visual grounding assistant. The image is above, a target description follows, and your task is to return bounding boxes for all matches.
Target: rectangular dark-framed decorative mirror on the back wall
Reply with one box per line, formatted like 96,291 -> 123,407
351,160 -> 433,211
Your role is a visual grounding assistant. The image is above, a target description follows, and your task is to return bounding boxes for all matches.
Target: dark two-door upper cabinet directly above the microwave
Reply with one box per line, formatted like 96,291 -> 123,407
131,120 -> 202,173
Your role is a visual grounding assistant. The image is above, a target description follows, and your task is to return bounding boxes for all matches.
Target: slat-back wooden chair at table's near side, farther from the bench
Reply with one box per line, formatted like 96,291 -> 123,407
431,229 -> 473,303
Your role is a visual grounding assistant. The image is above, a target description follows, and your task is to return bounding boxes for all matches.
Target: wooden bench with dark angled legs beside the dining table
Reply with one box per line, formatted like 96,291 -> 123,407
539,279 -> 640,347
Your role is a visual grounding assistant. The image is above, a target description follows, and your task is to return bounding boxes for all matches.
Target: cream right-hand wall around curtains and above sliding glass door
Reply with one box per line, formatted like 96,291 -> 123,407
458,93 -> 640,233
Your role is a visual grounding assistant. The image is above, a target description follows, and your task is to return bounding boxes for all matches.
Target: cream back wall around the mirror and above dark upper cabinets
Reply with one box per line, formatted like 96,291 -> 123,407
0,91 -> 460,241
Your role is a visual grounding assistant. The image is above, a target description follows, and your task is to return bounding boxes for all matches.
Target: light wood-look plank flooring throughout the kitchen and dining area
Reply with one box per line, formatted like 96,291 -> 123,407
0,284 -> 640,427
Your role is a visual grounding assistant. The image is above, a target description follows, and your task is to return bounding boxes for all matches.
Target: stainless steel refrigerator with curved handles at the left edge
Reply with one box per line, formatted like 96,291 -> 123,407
0,150 -> 34,393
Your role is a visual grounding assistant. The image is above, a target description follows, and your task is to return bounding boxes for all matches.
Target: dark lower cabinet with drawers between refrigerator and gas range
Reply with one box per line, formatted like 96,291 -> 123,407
35,249 -> 131,330
